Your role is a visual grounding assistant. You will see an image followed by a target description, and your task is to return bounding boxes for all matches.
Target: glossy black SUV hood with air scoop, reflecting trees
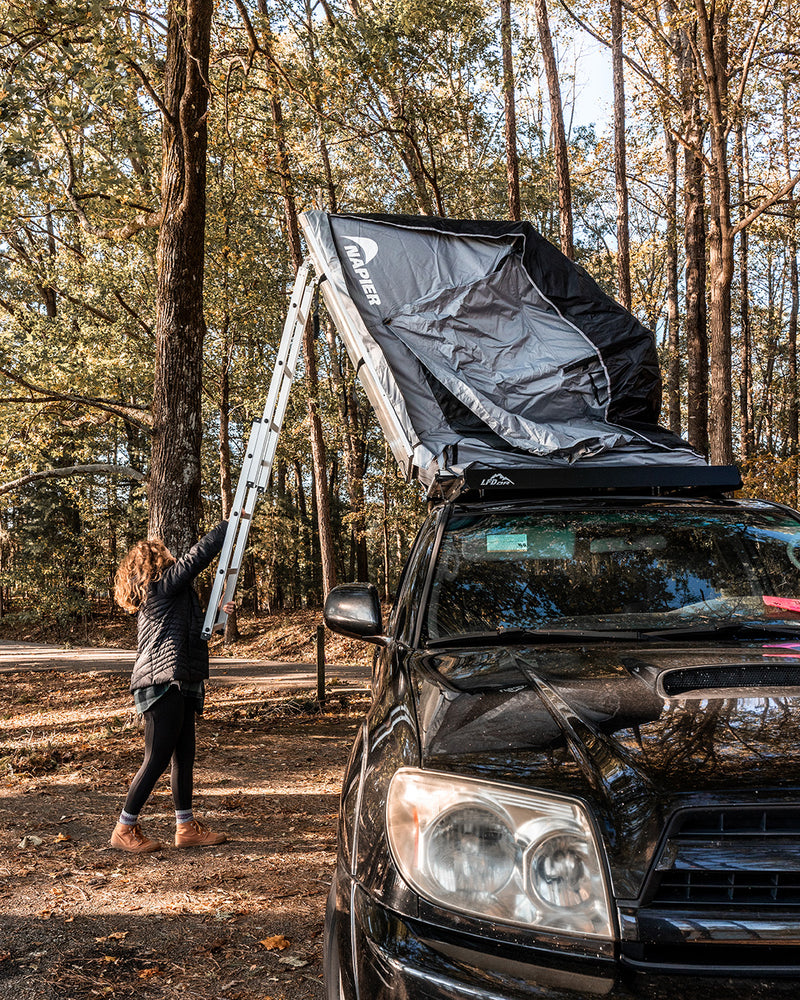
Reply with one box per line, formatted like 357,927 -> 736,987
409,642 -> 800,898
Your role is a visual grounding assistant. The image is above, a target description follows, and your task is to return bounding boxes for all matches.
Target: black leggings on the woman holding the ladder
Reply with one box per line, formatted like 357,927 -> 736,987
124,685 -> 195,816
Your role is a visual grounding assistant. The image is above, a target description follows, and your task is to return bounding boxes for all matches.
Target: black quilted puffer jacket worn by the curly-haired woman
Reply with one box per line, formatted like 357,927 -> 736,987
131,521 -> 228,691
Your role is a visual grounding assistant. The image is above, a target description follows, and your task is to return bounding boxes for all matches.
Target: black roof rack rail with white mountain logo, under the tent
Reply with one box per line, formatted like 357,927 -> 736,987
428,465 -> 742,502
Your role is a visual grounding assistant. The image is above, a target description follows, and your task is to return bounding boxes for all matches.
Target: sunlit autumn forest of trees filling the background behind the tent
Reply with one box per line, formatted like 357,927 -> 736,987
0,0 -> 800,620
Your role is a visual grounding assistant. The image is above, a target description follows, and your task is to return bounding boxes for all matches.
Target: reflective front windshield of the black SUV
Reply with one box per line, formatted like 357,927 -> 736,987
426,502 -> 800,640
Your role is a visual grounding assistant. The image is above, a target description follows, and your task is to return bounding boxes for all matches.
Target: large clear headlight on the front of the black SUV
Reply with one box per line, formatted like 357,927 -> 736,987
386,768 -> 614,940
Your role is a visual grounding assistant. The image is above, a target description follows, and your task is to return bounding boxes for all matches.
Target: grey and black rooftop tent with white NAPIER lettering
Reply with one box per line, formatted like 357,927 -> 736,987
301,212 -> 705,483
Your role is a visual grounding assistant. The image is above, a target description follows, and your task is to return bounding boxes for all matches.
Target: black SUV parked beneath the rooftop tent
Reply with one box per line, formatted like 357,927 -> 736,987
325,469 -> 800,1000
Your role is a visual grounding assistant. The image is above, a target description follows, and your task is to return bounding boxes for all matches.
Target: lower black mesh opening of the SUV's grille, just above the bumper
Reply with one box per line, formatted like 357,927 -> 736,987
654,870 -> 800,910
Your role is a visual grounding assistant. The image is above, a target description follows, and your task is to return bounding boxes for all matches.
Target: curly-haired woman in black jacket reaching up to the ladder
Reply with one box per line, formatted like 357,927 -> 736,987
111,521 -> 234,854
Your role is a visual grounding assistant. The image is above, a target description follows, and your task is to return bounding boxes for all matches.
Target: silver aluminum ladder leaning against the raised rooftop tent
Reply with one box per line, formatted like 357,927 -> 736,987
202,260 -> 319,639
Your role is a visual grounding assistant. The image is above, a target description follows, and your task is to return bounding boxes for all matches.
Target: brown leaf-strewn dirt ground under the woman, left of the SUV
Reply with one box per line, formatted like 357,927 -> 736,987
0,672 -> 367,1000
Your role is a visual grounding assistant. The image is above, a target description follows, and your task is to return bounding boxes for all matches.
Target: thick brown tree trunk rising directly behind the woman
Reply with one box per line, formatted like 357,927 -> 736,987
148,0 -> 213,555
